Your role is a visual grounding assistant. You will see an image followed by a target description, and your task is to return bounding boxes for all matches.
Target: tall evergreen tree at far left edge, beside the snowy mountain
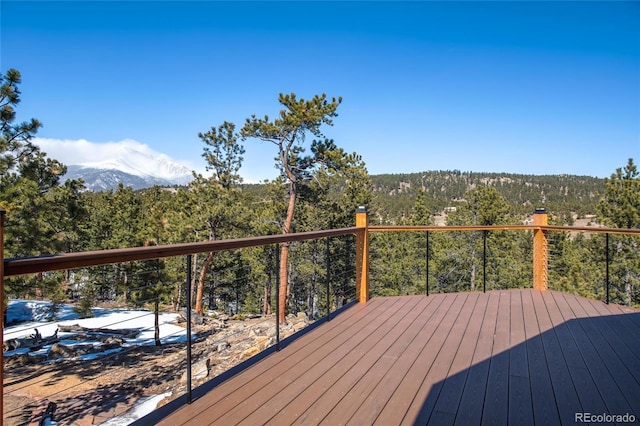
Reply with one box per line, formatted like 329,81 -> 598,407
0,69 -> 88,310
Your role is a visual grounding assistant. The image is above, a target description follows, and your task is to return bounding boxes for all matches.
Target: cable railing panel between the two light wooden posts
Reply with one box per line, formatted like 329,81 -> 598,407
370,228 -> 533,296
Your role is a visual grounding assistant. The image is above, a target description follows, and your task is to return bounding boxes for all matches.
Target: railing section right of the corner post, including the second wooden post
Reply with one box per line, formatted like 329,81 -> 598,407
365,213 -> 640,306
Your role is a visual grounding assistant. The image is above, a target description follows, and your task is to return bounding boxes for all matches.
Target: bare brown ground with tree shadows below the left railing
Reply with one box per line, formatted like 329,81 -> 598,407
3,317 -> 308,426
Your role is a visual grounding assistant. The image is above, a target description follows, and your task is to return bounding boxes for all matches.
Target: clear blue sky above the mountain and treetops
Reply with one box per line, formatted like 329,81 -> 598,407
0,0 -> 640,181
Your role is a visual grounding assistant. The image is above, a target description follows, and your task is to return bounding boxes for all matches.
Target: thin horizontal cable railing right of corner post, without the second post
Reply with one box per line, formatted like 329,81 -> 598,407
368,225 -> 640,306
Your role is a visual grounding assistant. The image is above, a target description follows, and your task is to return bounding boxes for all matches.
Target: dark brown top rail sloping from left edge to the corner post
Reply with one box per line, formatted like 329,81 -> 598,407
4,227 -> 365,277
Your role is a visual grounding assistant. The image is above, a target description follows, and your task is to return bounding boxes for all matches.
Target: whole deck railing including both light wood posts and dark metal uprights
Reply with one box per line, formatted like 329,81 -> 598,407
0,208 -> 640,424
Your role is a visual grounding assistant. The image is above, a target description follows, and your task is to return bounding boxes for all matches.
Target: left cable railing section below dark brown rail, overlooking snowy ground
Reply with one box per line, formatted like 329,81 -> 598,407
3,227 -> 365,424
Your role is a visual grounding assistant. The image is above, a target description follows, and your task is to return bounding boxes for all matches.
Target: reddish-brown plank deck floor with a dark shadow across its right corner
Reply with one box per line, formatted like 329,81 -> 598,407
155,290 -> 640,426
